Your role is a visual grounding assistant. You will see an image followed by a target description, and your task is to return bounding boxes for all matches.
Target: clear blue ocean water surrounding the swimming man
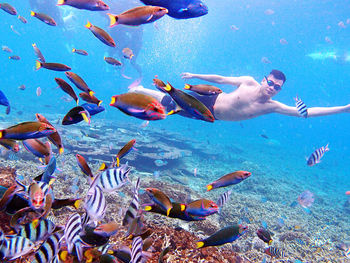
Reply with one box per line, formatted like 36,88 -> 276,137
0,0 -> 350,262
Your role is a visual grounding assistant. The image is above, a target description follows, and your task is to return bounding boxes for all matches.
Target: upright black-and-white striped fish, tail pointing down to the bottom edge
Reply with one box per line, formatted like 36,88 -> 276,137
64,213 -> 83,261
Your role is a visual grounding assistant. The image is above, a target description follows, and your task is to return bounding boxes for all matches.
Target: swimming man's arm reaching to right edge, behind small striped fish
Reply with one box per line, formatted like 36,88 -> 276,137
273,101 -> 350,117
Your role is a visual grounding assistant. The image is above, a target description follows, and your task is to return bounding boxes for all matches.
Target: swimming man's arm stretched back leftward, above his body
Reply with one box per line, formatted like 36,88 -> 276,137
181,72 -> 256,86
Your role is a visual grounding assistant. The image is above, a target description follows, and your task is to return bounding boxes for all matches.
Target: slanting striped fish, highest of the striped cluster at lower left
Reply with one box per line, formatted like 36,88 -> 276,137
91,164 -> 131,192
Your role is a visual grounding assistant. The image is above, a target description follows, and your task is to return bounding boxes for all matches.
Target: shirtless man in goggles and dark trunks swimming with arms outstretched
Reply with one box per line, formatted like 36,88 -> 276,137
129,70 -> 350,121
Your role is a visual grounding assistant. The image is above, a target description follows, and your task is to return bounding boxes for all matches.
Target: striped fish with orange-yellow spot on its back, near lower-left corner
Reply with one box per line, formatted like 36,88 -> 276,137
18,219 -> 55,242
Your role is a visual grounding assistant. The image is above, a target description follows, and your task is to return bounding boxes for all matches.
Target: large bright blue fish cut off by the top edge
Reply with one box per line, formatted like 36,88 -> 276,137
141,0 -> 208,19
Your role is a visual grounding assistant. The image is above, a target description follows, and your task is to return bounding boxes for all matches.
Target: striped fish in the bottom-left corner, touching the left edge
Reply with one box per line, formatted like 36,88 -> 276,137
0,236 -> 34,262
